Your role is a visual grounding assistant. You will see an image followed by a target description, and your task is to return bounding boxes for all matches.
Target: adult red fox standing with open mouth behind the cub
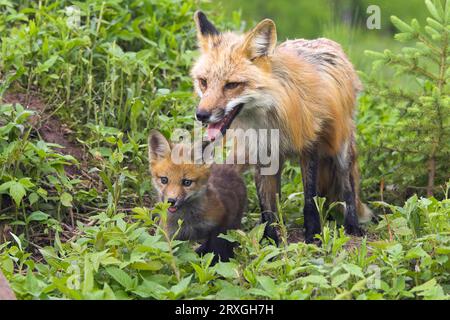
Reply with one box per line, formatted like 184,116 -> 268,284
191,11 -> 371,242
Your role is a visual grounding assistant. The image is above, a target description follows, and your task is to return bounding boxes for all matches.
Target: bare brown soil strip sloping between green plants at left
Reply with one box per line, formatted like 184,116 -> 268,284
2,93 -> 87,175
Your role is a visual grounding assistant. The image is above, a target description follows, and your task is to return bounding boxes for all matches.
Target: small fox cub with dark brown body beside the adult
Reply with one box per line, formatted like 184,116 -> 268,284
148,130 -> 247,262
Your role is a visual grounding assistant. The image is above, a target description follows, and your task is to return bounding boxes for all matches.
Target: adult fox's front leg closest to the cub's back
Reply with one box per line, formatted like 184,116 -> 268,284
255,161 -> 283,245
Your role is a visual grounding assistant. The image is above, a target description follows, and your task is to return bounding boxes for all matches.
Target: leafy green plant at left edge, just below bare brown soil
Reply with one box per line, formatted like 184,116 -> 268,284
0,104 -> 76,238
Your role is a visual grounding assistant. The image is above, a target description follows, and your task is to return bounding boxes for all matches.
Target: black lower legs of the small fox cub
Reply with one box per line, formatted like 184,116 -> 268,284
196,230 -> 237,265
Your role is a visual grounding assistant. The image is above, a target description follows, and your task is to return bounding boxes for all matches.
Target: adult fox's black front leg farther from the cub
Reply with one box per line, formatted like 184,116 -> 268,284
301,151 -> 321,243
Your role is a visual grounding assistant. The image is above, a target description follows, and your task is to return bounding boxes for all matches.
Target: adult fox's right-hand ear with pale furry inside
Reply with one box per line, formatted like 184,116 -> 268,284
244,19 -> 277,60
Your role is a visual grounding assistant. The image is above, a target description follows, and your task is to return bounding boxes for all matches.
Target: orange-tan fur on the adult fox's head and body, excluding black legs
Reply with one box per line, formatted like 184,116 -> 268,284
191,13 -> 367,221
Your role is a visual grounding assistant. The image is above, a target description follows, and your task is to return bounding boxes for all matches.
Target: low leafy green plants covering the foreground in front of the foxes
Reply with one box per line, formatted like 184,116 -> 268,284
0,195 -> 450,300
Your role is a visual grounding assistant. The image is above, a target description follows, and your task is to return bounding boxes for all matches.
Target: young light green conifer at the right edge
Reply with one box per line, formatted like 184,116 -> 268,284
362,0 -> 450,196
